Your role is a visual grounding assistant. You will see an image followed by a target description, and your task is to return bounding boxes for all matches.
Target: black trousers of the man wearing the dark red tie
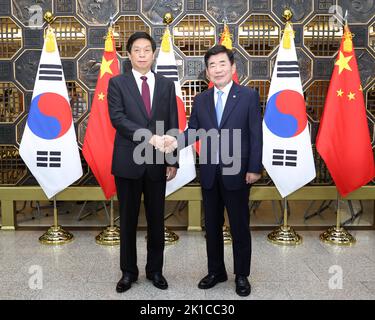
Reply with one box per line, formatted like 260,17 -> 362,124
115,171 -> 166,276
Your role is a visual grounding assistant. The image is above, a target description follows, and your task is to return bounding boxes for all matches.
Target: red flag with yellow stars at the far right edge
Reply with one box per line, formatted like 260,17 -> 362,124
316,26 -> 375,197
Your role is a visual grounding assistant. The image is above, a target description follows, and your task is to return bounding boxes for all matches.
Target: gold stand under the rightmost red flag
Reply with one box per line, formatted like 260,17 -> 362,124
320,193 -> 356,246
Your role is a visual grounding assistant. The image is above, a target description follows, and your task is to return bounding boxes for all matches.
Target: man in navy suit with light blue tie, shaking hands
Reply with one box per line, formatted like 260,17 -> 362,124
166,45 -> 262,296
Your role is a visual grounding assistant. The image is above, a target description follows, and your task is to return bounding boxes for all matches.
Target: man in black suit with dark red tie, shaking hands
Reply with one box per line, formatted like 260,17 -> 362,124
108,32 -> 178,292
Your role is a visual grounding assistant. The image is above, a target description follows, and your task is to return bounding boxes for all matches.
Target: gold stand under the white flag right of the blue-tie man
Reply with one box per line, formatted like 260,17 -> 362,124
267,197 -> 302,245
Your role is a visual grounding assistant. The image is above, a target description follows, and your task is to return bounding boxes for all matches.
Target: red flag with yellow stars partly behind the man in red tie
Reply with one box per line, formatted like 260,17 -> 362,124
82,28 -> 120,199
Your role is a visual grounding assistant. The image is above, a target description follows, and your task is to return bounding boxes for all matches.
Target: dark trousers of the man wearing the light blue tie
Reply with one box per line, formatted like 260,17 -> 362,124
202,166 -> 251,276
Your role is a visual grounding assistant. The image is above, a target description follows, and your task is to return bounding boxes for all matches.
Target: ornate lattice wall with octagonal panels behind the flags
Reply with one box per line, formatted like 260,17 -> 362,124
0,0 -> 375,185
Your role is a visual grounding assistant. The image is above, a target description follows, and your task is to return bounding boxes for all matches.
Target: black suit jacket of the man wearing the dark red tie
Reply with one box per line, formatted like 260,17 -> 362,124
108,71 -> 178,181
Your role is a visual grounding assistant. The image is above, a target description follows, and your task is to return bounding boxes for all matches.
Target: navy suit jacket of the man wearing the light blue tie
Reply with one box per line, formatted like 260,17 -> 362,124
184,82 -> 262,190
